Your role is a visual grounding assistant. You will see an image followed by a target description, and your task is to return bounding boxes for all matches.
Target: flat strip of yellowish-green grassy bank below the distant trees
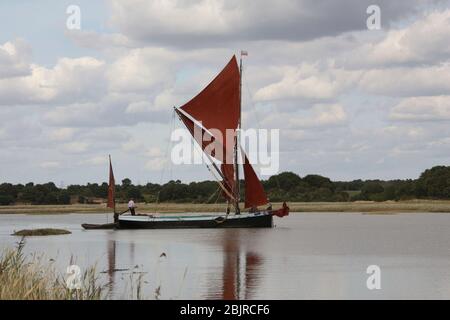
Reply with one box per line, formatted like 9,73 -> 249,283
0,200 -> 450,214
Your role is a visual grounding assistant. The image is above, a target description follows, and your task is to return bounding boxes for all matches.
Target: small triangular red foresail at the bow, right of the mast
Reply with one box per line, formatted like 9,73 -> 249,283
242,152 -> 269,209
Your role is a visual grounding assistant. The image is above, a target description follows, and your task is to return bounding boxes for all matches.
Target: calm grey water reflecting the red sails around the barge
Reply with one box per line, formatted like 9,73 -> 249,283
0,213 -> 450,299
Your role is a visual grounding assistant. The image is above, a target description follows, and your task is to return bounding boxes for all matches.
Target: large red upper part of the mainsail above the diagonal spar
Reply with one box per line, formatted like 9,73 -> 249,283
181,56 -> 240,163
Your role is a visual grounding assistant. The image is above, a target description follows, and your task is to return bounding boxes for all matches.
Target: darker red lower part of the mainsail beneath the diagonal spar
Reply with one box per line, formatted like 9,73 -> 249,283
175,109 -> 235,200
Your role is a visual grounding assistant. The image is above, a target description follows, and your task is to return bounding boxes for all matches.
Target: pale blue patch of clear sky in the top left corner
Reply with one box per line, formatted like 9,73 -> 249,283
0,0 -> 110,66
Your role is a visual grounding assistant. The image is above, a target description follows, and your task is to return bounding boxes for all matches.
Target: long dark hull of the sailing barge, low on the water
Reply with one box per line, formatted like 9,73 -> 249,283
118,214 -> 272,229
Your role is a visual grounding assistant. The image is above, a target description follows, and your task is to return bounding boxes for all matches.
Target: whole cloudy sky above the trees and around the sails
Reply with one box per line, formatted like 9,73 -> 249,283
0,0 -> 450,185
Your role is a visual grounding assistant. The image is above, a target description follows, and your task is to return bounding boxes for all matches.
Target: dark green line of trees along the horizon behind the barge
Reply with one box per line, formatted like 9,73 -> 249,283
0,166 -> 450,205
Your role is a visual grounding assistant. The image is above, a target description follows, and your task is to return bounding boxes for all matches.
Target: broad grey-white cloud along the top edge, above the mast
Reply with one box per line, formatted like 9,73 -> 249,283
110,0 -> 430,48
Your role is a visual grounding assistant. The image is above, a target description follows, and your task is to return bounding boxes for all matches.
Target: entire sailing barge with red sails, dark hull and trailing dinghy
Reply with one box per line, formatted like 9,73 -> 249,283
82,53 -> 289,229
